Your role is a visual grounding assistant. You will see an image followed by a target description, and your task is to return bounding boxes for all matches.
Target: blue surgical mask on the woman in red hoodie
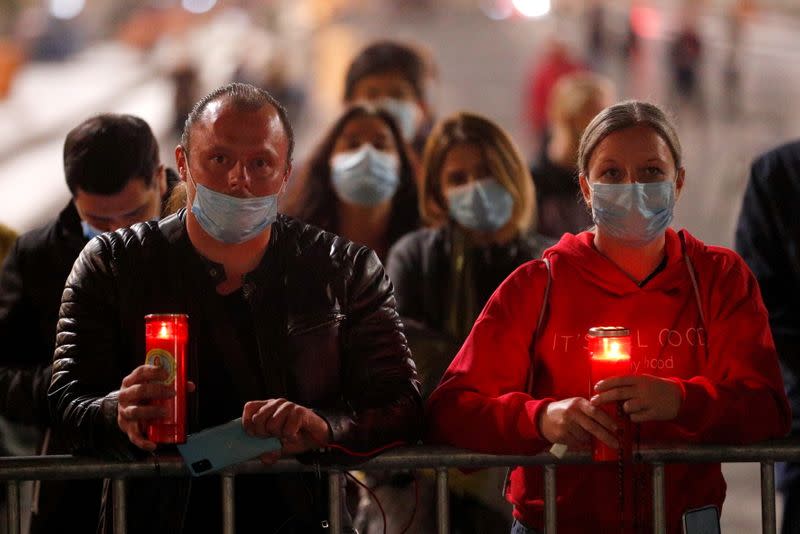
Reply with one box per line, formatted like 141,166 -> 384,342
591,180 -> 675,246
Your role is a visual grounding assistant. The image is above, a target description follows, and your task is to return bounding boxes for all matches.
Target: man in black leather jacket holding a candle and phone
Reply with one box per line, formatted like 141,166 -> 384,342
49,84 -> 421,534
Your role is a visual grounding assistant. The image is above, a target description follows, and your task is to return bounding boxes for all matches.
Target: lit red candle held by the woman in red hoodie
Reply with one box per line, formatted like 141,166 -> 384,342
587,326 -> 631,462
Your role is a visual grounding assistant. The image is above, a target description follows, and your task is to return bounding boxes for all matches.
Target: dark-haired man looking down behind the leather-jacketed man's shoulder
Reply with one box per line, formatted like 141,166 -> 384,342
0,114 -> 178,534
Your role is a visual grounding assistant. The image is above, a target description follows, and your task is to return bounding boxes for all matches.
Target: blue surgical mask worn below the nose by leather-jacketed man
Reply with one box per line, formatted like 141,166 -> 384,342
187,168 -> 279,244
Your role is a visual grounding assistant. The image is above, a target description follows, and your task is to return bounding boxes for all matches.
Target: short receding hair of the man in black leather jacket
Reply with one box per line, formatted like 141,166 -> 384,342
181,82 -> 294,165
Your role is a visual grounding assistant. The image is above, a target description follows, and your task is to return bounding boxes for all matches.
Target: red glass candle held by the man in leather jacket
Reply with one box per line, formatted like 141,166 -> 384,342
144,314 -> 189,443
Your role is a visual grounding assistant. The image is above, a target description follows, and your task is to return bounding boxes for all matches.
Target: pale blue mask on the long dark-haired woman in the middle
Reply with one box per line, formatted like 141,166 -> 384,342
331,143 -> 400,206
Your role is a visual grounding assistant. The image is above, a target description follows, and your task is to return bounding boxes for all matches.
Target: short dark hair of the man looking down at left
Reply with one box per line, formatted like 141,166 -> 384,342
64,113 -> 159,195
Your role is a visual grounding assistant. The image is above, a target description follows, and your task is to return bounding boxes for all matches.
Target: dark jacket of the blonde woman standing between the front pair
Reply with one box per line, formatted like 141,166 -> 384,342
386,224 -> 553,394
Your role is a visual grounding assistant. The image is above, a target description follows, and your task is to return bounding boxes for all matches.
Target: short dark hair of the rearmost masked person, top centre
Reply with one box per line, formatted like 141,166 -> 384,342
344,41 -> 435,102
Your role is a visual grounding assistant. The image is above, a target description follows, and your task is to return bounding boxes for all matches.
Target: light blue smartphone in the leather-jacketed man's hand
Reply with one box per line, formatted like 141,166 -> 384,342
178,417 -> 281,477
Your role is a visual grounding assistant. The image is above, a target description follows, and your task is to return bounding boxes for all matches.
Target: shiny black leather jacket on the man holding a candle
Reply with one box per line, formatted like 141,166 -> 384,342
49,210 -> 421,532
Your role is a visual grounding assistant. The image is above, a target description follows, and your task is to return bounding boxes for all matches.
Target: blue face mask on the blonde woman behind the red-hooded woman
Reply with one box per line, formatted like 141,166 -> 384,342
447,178 -> 514,232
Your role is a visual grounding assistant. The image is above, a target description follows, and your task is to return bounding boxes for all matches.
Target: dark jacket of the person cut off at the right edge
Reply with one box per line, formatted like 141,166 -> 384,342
736,141 -> 800,442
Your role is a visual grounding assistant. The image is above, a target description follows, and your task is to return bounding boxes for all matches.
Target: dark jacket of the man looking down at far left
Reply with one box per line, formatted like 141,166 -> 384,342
0,169 -> 184,534
